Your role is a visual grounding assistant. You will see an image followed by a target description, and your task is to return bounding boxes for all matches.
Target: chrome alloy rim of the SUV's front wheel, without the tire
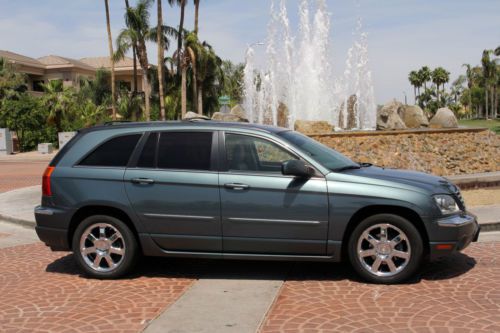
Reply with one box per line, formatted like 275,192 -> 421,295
357,223 -> 411,277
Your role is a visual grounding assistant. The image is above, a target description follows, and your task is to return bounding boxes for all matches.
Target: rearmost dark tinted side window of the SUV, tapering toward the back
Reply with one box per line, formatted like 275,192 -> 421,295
80,134 -> 141,167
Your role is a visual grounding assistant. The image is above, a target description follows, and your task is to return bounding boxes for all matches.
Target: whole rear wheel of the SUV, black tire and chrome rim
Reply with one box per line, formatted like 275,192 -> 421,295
72,215 -> 138,279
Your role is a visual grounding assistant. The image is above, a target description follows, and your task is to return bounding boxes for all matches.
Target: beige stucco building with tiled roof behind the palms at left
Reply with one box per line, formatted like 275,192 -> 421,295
0,50 -> 144,95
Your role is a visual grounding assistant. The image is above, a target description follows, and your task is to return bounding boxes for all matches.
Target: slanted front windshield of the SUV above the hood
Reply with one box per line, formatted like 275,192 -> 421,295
277,131 -> 360,171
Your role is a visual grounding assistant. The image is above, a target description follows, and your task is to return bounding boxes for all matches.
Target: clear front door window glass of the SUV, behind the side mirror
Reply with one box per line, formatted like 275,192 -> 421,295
226,134 -> 297,172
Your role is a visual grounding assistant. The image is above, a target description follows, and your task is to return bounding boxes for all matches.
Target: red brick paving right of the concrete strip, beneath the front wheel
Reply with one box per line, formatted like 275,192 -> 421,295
261,243 -> 500,333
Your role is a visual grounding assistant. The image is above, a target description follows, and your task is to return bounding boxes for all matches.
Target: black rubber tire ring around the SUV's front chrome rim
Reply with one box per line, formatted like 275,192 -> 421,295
348,214 -> 423,284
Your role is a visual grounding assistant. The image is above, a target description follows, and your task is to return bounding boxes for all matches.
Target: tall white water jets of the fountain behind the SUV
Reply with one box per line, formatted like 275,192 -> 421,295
244,0 -> 376,129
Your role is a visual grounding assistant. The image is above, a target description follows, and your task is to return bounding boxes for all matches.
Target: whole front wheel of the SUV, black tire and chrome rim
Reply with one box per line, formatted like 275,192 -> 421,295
348,214 -> 423,284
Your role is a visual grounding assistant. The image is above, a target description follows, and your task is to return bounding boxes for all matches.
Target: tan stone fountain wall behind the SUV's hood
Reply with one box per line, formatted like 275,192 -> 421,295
309,128 -> 500,176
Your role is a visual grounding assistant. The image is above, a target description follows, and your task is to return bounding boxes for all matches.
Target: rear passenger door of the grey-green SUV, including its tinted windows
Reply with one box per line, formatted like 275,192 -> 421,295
124,130 -> 222,252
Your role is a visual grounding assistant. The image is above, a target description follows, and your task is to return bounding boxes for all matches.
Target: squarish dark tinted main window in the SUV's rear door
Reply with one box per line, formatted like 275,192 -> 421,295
158,132 -> 213,170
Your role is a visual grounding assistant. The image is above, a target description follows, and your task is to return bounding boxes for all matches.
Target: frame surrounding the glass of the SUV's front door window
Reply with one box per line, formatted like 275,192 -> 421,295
218,130 -> 325,179
